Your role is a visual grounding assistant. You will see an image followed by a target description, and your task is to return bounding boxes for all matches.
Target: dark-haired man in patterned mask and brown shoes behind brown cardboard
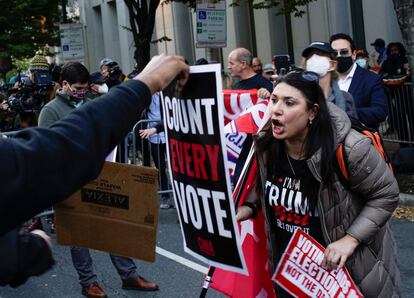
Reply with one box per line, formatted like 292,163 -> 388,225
39,62 -> 158,297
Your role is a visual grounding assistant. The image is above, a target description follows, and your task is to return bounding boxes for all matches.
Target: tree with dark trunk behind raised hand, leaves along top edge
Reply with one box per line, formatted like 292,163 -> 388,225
124,0 -> 317,70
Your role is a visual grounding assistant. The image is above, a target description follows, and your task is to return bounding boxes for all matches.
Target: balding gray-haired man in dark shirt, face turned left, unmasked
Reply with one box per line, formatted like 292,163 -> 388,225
227,48 -> 273,92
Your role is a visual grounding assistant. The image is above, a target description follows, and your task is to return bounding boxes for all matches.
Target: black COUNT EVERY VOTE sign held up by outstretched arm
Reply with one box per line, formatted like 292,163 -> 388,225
162,64 -> 246,274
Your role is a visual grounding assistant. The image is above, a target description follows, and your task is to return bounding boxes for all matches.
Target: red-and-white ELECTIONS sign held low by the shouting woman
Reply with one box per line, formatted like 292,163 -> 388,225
272,229 -> 363,298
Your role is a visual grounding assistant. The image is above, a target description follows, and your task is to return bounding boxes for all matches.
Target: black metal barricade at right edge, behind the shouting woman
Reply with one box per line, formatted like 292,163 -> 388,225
379,83 -> 414,144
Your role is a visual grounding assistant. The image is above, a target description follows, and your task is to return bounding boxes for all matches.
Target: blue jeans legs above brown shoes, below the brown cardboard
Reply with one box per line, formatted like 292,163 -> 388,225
70,247 -> 138,287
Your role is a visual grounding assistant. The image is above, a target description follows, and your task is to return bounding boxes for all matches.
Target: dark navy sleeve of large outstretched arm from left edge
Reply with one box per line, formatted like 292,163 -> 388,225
0,80 -> 151,235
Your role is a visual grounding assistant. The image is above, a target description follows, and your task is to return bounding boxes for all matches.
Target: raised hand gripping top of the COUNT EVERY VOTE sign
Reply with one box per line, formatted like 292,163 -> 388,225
134,54 -> 189,93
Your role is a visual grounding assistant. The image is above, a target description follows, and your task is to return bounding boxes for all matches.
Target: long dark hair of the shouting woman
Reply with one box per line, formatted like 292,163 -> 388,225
255,70 -> 335,209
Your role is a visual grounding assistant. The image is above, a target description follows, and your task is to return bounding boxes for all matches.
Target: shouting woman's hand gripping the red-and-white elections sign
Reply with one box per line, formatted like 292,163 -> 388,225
321,235 -> 359,270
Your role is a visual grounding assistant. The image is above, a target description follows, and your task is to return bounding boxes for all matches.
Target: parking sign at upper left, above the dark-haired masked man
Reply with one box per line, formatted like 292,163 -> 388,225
59,23 -> 85,62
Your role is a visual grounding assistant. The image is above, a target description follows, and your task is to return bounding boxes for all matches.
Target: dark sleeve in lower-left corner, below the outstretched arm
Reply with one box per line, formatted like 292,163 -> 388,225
0,229 -> 54,287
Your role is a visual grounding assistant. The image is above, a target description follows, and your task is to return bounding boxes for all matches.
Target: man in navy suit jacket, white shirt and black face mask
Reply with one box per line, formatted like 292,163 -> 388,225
330,33 -> 387,129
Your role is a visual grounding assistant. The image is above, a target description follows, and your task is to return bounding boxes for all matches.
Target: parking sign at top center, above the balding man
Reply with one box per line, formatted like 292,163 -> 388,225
196,0 -> 227,48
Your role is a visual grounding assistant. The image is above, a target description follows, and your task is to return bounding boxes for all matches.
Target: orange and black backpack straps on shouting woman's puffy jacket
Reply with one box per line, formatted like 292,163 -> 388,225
335,119 -> 393,185
